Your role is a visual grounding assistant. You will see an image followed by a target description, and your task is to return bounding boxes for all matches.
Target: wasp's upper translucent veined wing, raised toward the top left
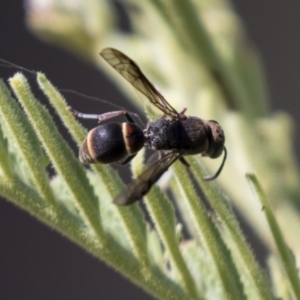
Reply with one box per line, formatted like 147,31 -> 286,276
100,48 -> 178,118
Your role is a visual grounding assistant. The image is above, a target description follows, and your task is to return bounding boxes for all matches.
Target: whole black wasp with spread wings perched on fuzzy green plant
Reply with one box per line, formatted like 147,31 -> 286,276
70,48 -> 227,205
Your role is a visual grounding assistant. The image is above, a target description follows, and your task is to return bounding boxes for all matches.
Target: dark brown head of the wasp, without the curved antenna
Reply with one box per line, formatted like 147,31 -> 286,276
206,120 -> 225,158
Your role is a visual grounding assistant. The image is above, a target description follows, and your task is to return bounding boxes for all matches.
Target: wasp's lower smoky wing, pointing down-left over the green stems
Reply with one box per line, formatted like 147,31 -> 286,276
113,152 -> 181,205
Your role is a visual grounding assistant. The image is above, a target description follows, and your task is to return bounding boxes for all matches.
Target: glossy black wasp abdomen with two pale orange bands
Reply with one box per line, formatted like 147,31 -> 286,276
79,123 -> 144,164
